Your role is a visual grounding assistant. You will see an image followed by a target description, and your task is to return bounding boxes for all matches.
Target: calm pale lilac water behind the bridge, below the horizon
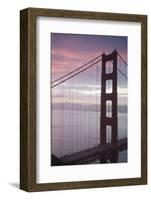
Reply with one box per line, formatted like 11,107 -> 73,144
51,109 -> 127,162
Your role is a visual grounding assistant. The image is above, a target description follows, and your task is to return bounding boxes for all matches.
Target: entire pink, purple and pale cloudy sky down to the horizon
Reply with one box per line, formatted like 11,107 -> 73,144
50,33 -> 127,111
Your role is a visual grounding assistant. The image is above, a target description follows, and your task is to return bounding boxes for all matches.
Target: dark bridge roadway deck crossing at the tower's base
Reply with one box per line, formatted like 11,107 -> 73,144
59,138 -> 127,165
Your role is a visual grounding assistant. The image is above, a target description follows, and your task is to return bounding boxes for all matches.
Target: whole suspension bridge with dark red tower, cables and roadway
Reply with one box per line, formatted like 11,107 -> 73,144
51,50 -> 127,166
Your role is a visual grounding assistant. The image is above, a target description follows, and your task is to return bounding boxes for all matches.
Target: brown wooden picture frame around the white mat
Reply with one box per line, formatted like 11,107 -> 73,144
20,8 -> 147,192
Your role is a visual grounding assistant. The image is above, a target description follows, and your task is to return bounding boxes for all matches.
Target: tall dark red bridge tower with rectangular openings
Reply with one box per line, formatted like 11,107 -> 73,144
100,50 -> 118,145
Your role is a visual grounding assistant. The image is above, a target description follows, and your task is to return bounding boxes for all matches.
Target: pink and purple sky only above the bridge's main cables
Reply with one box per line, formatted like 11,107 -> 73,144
51,33 -> 127,80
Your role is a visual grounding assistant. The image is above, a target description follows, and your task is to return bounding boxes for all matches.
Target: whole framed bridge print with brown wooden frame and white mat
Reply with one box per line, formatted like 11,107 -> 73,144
20,8 -> 147,192
